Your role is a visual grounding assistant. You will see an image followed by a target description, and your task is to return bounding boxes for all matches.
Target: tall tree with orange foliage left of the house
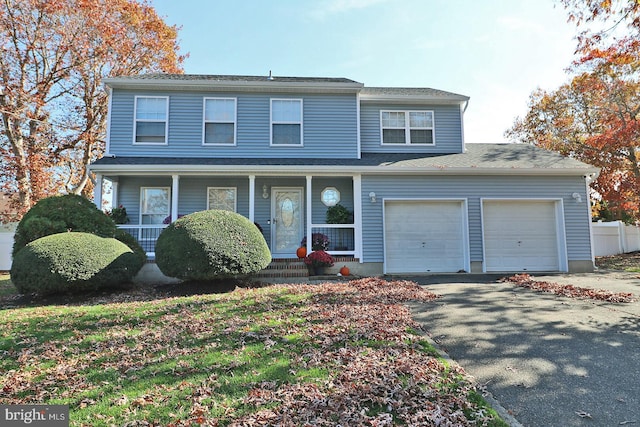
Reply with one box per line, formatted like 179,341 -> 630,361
0,0 -> 184,221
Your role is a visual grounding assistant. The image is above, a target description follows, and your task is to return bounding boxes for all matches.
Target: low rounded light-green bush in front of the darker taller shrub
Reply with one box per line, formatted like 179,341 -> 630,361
11,232 -> 142,295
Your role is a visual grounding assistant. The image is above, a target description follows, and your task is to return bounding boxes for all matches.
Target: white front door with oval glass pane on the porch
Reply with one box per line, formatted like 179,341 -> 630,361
271,187 -> 303,257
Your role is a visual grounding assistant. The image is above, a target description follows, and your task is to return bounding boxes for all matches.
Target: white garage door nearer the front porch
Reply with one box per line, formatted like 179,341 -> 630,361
384,201 -> 467,273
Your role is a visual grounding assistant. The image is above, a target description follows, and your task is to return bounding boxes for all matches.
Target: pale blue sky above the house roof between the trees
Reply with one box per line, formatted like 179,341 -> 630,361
152,0 -> 576,143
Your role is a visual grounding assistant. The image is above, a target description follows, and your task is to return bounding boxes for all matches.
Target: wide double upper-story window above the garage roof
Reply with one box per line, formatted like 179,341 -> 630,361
380,111 -> 435,145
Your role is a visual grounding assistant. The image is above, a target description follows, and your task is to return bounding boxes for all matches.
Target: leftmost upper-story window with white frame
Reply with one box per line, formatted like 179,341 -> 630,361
133,96 -> 169,144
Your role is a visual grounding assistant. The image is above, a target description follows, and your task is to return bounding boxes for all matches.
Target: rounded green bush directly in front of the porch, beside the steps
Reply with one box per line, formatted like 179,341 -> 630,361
156,210 -> 271,281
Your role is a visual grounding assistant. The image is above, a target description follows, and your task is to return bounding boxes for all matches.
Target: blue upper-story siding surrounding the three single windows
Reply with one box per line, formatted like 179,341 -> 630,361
109,90 -> 358,158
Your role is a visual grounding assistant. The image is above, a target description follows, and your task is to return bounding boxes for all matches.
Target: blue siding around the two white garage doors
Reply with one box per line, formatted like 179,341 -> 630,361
362,176 -> 591,262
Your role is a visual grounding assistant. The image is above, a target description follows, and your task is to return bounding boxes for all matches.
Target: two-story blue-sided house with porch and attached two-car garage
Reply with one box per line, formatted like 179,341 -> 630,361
91,74 -> 598,274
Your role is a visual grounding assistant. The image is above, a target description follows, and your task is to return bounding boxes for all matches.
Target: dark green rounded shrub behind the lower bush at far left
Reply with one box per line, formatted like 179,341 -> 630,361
12,194 -> 116,257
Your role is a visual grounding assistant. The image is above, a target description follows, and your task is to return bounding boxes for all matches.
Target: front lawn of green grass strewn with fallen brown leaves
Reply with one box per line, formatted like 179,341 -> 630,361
0,279 -> 506,426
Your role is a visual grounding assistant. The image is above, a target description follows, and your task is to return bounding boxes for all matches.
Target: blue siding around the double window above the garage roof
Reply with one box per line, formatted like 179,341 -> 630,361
360,103 -> 462,153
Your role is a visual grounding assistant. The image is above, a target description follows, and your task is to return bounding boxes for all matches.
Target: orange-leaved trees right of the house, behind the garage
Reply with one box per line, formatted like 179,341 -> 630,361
505,0 -> 640,221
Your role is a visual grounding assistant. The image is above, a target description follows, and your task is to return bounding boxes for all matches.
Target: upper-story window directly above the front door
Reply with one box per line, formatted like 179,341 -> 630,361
271,99 -> 302,146
